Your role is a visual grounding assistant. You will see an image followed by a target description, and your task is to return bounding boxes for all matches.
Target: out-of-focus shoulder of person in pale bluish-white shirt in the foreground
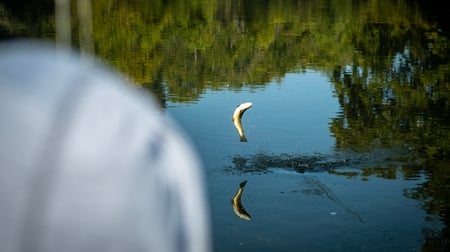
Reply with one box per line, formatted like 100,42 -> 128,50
0,41 -> 210,252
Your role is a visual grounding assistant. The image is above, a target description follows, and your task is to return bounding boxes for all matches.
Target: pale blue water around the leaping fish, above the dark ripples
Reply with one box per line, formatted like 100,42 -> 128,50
167,71 -> 339,167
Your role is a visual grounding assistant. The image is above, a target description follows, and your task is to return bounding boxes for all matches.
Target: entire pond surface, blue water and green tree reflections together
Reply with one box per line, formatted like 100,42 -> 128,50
0,0 -> 450,251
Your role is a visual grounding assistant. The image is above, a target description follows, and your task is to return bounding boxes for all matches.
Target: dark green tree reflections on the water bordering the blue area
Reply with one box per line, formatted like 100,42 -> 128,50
0,0 -> 450,250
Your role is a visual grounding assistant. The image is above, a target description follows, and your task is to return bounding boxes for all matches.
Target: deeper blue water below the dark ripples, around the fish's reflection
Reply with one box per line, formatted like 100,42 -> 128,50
209,172 -> 433,251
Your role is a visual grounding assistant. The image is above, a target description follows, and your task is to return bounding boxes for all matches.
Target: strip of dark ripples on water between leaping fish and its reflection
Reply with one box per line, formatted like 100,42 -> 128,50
226,148 -> 422,180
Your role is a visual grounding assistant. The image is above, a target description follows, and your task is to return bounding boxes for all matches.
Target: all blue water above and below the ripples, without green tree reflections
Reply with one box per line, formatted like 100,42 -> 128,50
167,71 -> 442,251
